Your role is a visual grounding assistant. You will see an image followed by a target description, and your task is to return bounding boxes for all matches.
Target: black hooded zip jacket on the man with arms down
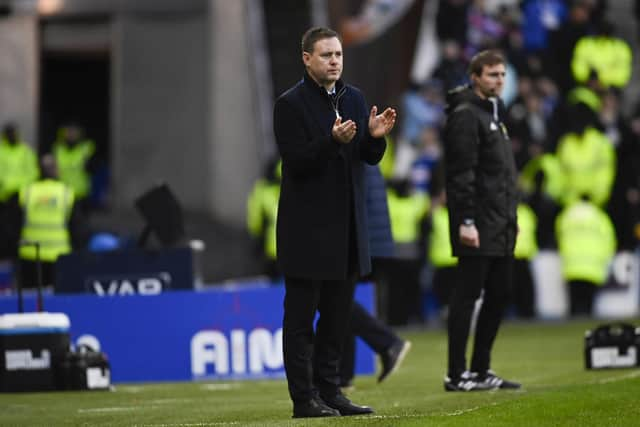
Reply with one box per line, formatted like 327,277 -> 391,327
444,86 -> 518,256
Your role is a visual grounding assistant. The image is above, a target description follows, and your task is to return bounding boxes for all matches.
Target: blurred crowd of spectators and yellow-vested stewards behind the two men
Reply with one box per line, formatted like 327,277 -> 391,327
249,0 -> 640,325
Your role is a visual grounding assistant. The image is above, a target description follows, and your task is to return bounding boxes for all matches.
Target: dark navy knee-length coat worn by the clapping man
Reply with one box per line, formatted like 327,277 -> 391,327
274,73 -> 386,280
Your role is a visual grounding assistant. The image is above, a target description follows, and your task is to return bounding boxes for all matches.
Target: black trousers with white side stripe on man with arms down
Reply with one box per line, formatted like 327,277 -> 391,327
448,256 -> 513,378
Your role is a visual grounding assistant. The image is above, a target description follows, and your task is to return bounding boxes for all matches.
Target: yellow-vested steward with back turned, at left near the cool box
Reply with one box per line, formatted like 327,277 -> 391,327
18,155 -> 74,287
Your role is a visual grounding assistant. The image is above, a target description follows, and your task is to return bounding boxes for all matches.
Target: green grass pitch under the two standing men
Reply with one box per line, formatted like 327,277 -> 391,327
0,320 -> 640,427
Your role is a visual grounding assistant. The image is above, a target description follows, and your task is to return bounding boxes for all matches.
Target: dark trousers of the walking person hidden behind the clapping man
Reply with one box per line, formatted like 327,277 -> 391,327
340,302 -> 400,386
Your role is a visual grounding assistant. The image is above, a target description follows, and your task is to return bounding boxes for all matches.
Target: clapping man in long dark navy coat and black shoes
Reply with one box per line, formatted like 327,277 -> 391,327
273,28 -> 396,417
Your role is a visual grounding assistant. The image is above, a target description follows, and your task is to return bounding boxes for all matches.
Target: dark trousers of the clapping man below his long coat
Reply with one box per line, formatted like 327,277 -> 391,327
282,275 -> 356,403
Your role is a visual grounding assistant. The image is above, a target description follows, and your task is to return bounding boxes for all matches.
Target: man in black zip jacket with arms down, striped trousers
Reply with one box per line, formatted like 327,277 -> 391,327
444,51 -> 520,391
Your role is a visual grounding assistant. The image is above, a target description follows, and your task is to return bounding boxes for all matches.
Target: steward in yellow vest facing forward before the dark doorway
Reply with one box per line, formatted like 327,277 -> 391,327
52,125 -> 96,199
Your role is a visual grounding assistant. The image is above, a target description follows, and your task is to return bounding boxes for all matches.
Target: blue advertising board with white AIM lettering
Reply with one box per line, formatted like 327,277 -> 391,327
0,283 -> 375,382
